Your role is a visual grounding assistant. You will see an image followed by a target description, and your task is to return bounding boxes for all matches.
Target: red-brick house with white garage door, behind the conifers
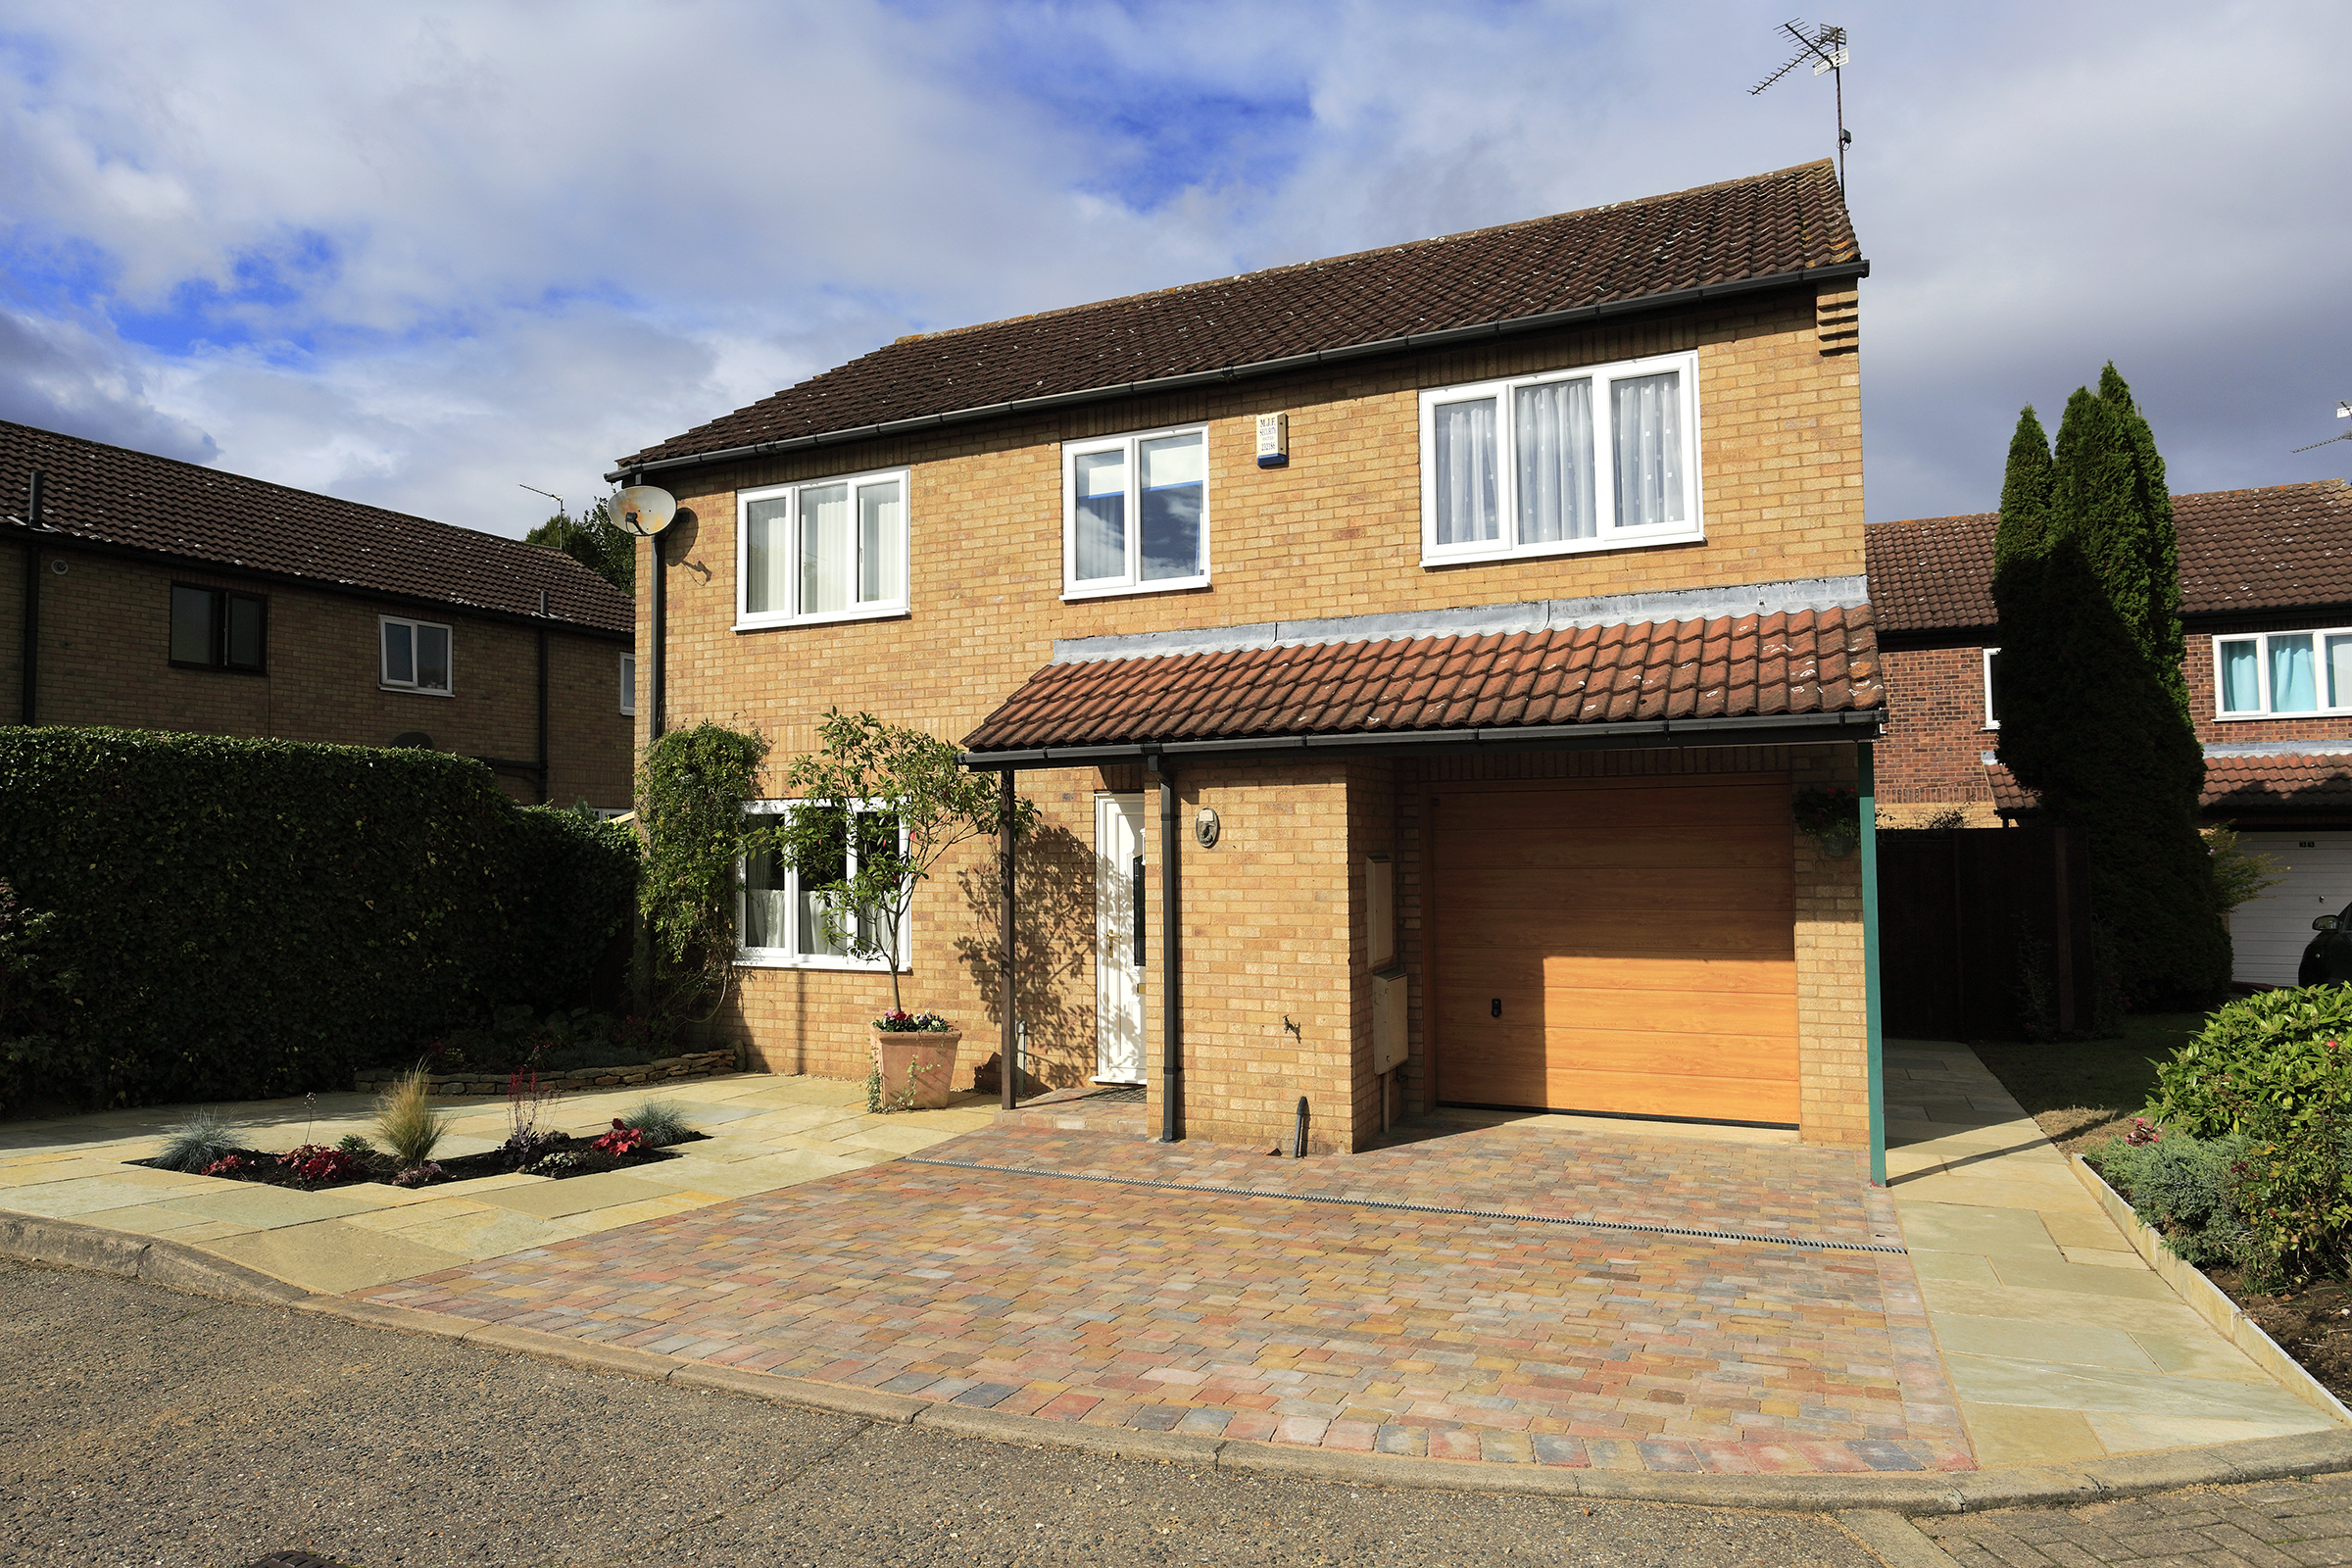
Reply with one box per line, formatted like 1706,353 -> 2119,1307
1868,479 -> 2352,985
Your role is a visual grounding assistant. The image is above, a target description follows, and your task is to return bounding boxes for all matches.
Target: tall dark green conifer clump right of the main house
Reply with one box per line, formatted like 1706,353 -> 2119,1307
1992,390 -> 2230,1006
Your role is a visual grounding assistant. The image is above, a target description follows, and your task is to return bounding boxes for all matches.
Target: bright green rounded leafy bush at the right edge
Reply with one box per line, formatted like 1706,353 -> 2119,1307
2147,985 -> 2352,1138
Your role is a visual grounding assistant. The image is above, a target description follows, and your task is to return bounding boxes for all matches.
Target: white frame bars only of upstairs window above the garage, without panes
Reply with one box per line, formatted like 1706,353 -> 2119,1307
1421,353 -> 1707,566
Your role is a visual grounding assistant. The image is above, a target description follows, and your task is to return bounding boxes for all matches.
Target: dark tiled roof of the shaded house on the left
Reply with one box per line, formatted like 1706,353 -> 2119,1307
0,420 -> 637,632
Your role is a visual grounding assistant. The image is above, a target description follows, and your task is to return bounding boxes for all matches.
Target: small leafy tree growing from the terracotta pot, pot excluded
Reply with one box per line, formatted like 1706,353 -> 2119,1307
776,708 -> 1037,1010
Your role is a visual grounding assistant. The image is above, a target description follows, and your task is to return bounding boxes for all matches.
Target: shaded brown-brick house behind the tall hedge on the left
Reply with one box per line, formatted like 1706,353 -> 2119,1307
0,420 -> 635,808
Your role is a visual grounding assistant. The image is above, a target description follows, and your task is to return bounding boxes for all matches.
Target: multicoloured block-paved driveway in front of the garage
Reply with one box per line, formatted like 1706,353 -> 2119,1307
355,1116 -> 1974,1472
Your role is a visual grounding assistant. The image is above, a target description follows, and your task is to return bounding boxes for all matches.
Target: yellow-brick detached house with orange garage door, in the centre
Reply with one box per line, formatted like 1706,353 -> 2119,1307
613,163 -> 1882,1150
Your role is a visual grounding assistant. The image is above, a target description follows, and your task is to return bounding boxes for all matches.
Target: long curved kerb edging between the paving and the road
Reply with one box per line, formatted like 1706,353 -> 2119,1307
0,1210 -> 2352,1514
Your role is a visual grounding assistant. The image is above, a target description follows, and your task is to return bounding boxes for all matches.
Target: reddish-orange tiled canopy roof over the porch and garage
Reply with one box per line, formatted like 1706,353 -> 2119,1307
964,607 -> 1884,753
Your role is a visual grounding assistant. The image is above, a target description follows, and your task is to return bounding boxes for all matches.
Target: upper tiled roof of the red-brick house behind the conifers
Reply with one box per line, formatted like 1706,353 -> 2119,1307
1863,479 -> 2352,635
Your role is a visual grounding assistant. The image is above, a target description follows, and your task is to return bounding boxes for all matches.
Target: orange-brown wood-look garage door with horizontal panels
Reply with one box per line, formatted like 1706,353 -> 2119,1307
1433,773 -> 1797,1124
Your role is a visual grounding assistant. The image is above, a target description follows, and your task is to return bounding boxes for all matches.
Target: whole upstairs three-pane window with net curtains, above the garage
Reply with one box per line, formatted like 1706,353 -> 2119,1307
1421,353 -> 1705,566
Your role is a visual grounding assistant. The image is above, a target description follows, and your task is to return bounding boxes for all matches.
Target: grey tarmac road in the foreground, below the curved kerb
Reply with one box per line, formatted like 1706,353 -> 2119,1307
0,1260 -> 1882,1568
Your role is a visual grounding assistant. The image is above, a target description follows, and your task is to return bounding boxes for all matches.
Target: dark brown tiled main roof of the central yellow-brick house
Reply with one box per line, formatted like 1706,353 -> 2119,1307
618,160 -> 1860,467
